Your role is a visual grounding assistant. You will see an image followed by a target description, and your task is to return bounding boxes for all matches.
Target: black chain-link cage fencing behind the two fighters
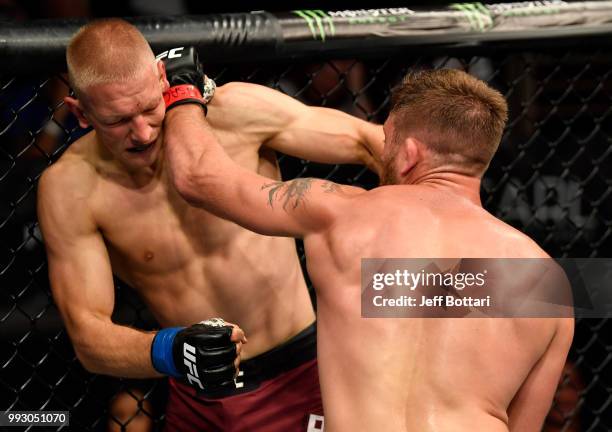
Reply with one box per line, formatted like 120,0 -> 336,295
0,38 -> 612,431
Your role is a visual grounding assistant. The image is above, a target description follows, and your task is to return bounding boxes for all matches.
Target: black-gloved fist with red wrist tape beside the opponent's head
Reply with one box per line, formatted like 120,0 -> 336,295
157,47 -> 214,114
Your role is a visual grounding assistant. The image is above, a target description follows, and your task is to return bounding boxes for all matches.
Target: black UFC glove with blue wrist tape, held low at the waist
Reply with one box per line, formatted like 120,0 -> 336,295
151,318 -> 238,390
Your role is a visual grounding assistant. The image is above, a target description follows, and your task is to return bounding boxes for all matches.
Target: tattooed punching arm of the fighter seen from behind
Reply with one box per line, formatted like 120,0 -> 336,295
164,104 -> 362,237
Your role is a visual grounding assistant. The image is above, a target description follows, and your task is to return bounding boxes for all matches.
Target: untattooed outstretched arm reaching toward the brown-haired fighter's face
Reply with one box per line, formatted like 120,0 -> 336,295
210,82 -> 384,173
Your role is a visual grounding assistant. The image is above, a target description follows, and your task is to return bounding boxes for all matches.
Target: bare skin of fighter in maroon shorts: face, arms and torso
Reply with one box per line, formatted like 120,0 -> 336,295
38,61 -> 382,377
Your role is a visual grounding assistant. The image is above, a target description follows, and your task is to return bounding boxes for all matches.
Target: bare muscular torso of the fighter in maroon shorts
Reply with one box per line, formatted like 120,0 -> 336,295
64,92 -> 314,358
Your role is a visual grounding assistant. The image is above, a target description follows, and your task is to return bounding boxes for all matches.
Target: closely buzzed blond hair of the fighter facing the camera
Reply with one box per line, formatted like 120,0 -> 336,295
66,18 -> 155,97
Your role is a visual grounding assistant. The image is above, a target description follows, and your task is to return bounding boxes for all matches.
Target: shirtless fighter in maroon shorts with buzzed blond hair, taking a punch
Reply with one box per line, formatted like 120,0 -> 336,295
38,19 -> 383,432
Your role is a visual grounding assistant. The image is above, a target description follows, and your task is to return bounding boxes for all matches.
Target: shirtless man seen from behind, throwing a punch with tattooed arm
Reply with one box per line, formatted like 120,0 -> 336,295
164,66 -> 573,432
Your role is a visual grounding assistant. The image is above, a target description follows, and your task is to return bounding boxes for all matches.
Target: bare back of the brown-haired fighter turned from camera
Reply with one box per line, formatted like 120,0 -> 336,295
307,185 -> 572,432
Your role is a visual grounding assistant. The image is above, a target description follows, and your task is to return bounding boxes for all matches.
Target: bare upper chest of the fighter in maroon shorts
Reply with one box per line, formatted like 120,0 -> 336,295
97,177 -> 239,273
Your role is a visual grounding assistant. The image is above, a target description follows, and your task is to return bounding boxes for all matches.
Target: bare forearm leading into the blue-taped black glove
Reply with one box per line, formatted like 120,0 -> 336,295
71,318 -> 161,378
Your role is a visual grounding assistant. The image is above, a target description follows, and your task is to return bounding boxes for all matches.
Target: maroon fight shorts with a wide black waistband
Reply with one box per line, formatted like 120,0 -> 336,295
164,324 -> 323,432
